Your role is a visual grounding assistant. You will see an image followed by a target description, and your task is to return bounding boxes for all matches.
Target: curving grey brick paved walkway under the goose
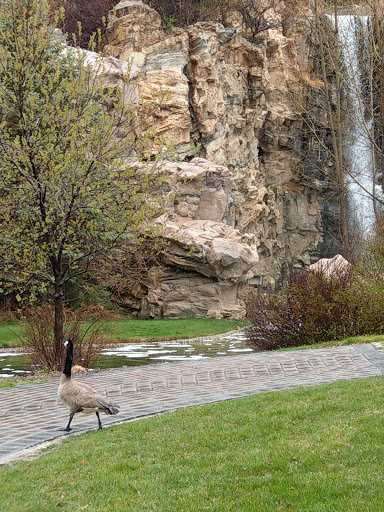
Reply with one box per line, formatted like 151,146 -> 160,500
0,345 -> 384,464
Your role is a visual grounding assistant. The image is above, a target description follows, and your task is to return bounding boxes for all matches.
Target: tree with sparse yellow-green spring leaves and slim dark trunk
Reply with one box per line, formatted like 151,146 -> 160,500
0,0 -> 162,365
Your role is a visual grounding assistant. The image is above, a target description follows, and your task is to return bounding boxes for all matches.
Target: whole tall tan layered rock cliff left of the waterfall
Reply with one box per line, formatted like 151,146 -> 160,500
106,0 -> 332,317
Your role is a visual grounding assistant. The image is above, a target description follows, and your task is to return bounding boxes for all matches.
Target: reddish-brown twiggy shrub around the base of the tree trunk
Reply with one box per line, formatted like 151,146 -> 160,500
23,304 -> 111,370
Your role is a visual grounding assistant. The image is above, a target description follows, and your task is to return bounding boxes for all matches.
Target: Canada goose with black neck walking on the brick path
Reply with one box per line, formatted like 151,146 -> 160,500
58,339 -> 119,432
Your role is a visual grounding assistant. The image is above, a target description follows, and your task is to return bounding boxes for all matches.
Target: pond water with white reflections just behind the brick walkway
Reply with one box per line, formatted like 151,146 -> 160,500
0,331 -> 253,378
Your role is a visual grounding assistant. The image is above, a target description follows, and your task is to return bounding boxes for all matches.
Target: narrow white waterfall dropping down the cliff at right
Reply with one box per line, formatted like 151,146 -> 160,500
338,15 -> 382,235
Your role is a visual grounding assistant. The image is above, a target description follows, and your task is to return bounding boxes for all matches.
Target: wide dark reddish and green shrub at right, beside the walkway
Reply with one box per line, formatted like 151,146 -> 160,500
247,269 -> 384,350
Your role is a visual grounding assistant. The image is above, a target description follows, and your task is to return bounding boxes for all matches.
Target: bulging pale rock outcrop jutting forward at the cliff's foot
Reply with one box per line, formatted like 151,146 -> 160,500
140,158 -> 259,318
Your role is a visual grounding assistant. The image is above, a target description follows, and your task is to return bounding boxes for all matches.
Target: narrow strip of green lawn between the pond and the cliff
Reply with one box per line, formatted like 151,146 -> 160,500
0,318 -> 247,347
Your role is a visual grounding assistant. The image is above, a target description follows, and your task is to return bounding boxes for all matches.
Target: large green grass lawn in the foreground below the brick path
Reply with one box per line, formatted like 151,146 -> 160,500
0,377 -> 384,512
